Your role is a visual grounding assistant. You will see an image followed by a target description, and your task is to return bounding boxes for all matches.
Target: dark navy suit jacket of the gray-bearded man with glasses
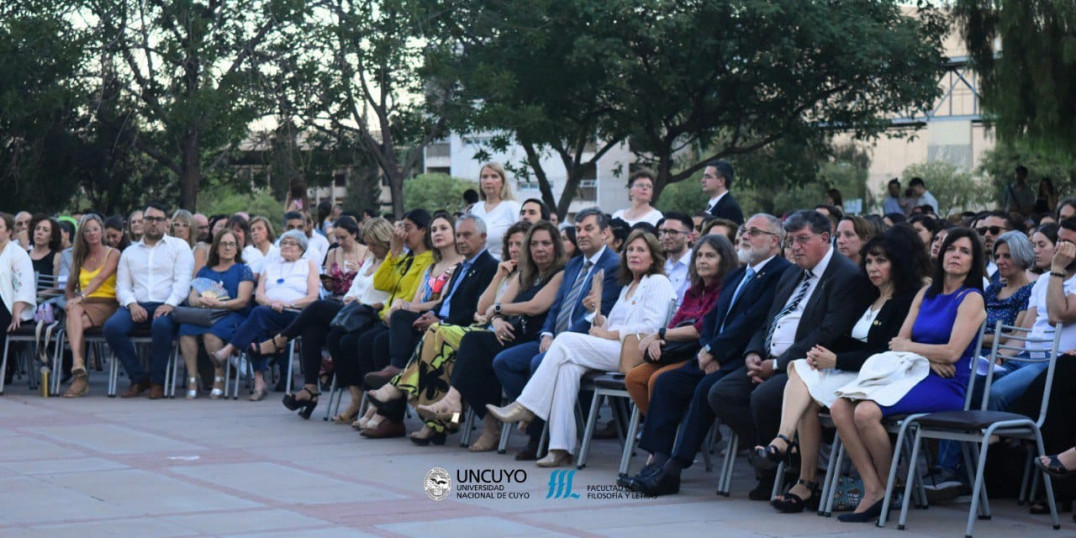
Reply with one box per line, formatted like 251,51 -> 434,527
699,256 -> 792,366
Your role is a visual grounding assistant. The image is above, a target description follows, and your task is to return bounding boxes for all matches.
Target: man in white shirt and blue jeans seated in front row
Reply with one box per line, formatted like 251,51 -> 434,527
102,203 -> 195,399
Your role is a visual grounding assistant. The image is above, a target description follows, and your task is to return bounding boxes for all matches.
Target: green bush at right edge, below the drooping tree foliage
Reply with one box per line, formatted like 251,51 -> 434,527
977,141 -> 1076,204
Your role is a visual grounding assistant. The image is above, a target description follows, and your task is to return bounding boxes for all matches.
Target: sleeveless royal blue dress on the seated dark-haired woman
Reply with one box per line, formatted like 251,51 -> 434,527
879,287 -> 982,416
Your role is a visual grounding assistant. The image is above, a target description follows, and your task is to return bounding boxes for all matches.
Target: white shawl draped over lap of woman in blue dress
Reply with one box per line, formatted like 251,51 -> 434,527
837,351 -> 931,406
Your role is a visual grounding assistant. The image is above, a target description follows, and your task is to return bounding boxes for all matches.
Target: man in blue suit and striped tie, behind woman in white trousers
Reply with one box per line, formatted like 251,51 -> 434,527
493,208 -> 620,459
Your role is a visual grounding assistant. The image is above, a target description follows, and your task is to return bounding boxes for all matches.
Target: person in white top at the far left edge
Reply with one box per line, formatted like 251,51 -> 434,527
0,213 -> 38,355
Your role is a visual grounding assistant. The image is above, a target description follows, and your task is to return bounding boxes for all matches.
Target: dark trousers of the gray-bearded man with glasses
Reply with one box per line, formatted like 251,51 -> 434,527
639,359 -> 745,468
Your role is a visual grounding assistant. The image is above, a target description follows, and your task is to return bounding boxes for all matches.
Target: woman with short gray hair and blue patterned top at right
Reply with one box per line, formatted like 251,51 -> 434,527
982,231 -> 1035,345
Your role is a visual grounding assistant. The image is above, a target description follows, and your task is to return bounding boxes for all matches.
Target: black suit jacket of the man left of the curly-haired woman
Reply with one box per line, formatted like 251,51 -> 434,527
747,246 -> 874,371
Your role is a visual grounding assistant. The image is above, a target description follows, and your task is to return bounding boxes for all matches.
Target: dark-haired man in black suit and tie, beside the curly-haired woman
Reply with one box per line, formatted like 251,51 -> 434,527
708,210 -> 870,500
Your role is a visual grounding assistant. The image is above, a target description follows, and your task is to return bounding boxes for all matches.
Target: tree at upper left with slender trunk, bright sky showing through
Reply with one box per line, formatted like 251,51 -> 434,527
85,0 -> 305,209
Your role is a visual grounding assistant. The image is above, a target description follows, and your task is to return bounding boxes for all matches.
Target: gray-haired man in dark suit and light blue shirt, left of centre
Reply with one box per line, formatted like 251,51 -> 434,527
366,215 -> 497,386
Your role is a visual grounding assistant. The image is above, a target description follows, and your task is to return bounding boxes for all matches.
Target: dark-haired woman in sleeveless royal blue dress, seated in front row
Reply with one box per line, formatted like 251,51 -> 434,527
831,228 -> 987,522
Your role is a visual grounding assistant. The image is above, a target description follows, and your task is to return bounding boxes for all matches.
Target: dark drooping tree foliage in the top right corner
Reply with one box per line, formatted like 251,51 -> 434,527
953,0 -> 1076,154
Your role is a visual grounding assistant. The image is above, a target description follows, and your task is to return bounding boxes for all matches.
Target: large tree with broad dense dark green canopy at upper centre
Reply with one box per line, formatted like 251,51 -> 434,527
430,0 -> 948,214
